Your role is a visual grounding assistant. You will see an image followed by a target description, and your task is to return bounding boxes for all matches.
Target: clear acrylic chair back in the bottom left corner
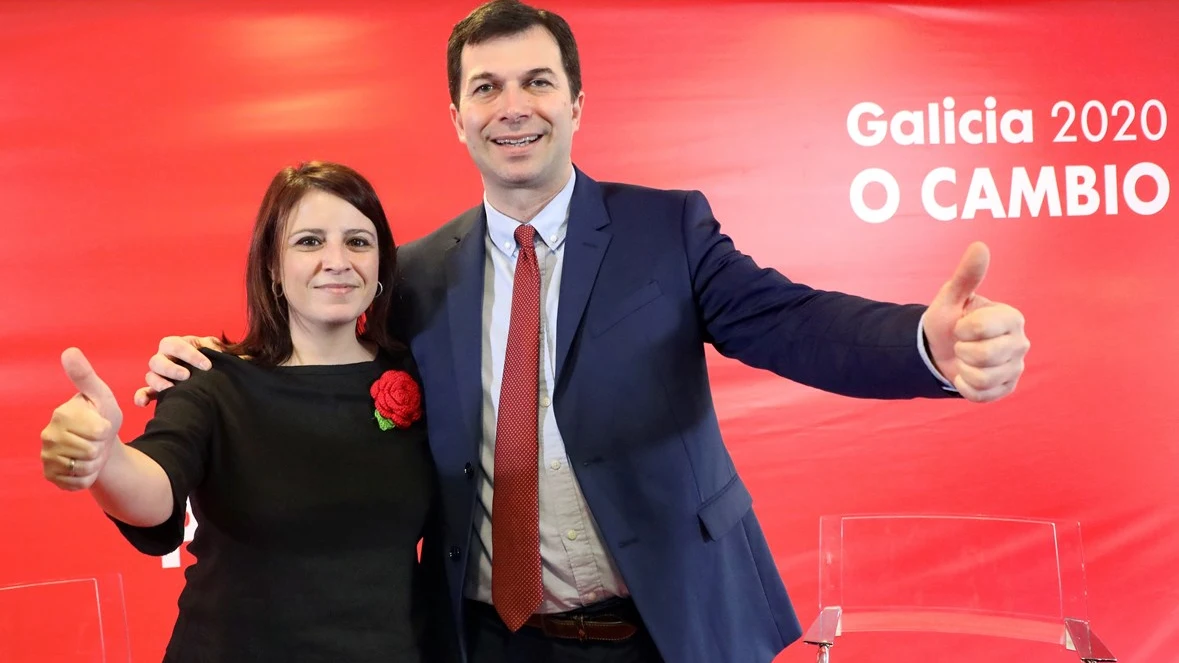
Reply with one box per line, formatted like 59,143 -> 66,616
0,575 -> 131,663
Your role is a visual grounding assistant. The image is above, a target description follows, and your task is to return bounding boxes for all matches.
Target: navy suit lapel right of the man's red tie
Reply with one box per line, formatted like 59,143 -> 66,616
556,170 -> 611,385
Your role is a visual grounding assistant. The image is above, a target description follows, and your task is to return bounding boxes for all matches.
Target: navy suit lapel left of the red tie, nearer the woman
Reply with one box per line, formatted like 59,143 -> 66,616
446,205 -> 487,448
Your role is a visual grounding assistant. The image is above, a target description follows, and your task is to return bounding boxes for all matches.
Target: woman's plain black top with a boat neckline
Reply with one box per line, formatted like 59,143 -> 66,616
117,350 -> 435,663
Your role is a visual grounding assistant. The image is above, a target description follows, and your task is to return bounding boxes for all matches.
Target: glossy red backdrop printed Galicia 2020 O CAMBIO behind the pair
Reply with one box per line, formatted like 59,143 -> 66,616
0,0 -> 1179,663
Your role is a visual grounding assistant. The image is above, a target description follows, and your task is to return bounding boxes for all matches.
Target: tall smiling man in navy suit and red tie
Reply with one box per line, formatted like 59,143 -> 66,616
119,0 -> 1028,663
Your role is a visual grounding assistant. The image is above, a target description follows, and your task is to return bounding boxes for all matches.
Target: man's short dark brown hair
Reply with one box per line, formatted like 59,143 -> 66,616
446,0 -> 581,107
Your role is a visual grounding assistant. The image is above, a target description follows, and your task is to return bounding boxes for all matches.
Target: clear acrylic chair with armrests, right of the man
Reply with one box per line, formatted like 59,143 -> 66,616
805,514 -> 1114,661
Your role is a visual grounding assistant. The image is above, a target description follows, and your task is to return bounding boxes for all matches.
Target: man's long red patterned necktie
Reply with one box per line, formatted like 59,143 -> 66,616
492,223 -> 544,631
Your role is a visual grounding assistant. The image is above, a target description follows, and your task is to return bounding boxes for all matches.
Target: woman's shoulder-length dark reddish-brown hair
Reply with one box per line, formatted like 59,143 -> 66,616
223,162 -> 404,366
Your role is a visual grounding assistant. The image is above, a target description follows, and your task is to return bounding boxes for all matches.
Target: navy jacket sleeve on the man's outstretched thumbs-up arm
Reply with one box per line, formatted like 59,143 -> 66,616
683,191 -> 953,399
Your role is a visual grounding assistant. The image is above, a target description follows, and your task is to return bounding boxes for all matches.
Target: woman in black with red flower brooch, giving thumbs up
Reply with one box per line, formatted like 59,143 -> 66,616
41,163 -> 444,662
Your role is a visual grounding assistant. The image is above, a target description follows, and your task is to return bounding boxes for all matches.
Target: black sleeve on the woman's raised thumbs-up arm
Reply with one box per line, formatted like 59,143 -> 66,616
111,368 -> 216,556
